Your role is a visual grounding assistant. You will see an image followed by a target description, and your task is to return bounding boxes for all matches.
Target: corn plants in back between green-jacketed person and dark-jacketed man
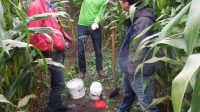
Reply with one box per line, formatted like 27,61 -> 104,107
102,0 -> 126,48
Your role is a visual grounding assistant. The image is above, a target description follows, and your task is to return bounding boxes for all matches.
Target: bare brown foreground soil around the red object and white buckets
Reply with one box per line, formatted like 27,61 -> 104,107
35,90 -> 121,112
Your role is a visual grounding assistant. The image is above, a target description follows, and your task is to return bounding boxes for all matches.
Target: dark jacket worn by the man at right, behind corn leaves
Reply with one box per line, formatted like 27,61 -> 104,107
119,7 -> 155,78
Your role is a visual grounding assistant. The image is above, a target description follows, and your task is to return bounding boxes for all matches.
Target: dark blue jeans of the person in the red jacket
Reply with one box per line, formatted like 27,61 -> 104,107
43,51 -> 65,112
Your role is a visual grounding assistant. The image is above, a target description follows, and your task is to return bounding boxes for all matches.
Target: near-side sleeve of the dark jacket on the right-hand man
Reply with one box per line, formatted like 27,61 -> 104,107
127,17 -> 155,76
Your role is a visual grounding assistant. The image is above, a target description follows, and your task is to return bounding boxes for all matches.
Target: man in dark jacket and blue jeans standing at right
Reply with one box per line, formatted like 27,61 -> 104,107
118,0 -> 158,112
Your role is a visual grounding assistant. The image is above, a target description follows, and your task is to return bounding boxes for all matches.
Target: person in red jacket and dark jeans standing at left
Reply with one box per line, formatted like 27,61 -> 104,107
28,0 -> 76,112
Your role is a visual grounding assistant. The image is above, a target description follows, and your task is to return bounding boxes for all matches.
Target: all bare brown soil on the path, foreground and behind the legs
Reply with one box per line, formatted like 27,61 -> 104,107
35,39 -> 121,112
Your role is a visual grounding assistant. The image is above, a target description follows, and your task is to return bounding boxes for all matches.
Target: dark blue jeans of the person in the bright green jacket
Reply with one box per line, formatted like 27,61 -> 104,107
78,25 -> 102,73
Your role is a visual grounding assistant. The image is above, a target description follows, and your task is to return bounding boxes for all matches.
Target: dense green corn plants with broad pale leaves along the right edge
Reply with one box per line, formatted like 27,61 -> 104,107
132,0 -> 200,112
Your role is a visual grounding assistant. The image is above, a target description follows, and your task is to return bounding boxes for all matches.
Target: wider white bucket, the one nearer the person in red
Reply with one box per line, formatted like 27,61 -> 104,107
66,78 -> 86,99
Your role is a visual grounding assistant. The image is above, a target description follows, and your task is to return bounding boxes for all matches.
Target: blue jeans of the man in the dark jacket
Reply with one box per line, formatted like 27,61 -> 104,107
119,73 -> 158,112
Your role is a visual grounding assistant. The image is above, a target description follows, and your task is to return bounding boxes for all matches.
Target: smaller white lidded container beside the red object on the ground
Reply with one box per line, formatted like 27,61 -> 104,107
90,82 -> 103,100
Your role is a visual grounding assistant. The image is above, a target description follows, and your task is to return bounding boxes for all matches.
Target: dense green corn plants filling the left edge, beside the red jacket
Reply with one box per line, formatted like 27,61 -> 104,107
0,0 -> 68,112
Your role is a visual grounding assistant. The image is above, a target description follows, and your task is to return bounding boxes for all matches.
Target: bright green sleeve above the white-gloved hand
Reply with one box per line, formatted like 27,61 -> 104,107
94,0 -> 108,23
